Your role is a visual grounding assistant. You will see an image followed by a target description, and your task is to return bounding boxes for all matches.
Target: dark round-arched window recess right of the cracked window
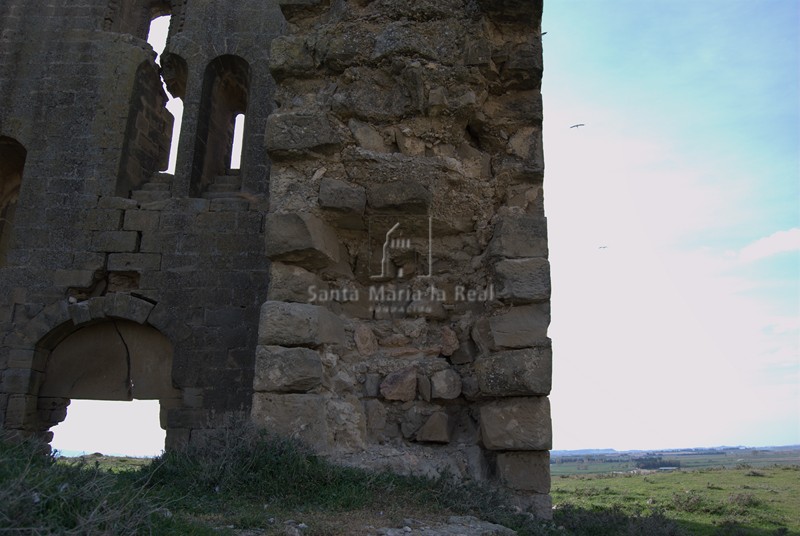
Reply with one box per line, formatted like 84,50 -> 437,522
190,54 -> 251,197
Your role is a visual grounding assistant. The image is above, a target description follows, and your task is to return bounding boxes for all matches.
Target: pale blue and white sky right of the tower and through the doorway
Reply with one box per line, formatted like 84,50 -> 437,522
54,0 -> 800,454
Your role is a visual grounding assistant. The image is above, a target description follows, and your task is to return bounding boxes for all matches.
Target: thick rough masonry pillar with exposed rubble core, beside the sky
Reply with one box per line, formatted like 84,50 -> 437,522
253,0 -> 551,515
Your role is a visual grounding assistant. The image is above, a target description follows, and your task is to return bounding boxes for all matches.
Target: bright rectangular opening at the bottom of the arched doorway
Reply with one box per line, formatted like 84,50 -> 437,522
51,400 -> 166,456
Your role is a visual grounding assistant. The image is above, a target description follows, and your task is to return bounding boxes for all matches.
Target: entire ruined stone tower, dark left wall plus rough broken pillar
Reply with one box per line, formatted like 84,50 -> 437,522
0,0 -> 551,516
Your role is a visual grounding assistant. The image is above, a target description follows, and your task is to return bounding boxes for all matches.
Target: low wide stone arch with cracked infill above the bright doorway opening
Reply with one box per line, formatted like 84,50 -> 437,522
4,294 -> 190,442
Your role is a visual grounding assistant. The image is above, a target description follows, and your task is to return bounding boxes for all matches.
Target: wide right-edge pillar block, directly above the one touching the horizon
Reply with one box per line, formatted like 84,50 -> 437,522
475,346 -> 553,396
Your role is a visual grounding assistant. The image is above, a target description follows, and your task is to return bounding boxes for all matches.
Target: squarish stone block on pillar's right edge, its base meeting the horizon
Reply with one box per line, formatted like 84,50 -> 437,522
480,397 -> 553,450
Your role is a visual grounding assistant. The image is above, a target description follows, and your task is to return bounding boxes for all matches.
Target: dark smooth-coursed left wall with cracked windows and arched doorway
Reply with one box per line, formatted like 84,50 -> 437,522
0,0 -> 282,447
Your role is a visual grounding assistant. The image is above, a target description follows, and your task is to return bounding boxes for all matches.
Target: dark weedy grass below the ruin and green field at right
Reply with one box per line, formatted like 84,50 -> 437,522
0,429 -> 800,536
